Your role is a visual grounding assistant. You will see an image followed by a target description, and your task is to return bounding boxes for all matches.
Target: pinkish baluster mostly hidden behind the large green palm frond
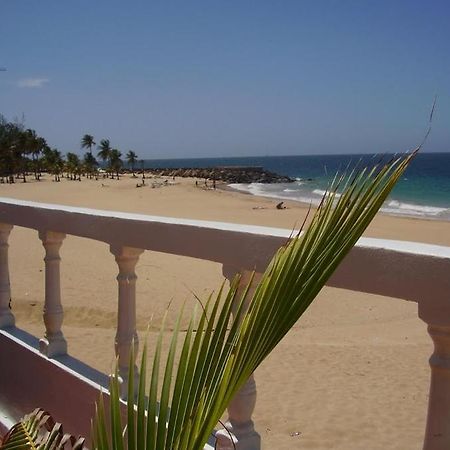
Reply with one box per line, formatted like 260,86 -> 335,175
218,266 -> 261,450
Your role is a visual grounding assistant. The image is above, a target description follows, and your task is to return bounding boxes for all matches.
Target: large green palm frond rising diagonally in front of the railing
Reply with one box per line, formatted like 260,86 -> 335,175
93,152 -> 415,450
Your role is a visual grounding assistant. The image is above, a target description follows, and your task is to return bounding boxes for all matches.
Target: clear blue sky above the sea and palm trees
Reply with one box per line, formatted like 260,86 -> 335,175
0,0 -> 450,158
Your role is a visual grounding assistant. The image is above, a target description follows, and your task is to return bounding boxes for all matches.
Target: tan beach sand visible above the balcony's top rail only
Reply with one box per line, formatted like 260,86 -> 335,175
0,175 -> 450,246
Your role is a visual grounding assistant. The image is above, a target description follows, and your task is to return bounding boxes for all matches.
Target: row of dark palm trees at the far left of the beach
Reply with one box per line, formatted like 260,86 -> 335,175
0,114 -> 138,183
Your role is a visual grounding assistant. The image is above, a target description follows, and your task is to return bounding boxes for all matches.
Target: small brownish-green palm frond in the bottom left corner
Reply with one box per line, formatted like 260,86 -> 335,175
0,409 -> 85,450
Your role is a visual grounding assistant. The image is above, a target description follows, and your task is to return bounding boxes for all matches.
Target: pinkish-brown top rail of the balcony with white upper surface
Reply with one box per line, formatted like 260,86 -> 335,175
0,197 -> 450,312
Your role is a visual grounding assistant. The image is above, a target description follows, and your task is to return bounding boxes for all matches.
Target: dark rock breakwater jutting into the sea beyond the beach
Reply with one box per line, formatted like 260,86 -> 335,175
146,166 -> 295,184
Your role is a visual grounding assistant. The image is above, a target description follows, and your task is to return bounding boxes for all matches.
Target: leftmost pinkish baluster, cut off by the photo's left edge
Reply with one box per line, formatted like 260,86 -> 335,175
0,223 -> 15,328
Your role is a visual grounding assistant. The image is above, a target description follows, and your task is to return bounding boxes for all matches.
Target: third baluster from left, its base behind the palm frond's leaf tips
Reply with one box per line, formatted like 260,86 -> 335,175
110,245 -> 143,399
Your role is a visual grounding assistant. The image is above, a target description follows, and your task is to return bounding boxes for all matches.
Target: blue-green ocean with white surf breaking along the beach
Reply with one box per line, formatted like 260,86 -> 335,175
144,153 -> 450,220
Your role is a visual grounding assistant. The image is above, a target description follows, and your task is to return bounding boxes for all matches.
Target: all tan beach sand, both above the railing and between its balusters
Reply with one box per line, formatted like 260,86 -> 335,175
0,176 -> 450,450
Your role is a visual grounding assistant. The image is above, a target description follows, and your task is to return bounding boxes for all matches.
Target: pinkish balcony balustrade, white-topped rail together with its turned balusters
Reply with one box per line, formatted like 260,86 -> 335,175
0,198 -> 450,450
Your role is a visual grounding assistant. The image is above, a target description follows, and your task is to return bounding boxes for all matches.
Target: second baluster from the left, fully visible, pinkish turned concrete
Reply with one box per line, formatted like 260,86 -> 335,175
39,231 -> 67,358
